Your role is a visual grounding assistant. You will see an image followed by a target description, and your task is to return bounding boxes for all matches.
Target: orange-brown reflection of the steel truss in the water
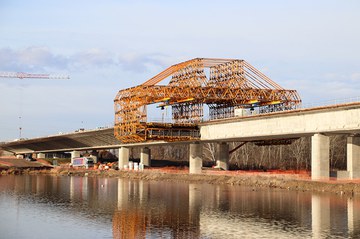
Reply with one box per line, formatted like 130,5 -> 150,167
113,179 -> 200,238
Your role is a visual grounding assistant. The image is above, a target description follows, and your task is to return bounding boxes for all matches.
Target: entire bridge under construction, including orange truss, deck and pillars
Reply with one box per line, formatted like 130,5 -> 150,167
0,58 -> 360,180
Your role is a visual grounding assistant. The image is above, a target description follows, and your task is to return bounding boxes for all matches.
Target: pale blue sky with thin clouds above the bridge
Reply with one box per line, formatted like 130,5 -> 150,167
0,0 -> 360,142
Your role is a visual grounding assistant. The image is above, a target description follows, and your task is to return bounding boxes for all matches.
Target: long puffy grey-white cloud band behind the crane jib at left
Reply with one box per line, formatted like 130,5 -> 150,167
0,46 -> 175,73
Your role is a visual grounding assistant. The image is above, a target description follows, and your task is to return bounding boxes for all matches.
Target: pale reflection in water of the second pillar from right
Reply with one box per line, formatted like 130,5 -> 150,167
311,194 -> 330,238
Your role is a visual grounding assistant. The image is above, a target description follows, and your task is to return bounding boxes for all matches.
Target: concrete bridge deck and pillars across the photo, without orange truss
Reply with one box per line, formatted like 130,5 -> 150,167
0,102 -> 360,179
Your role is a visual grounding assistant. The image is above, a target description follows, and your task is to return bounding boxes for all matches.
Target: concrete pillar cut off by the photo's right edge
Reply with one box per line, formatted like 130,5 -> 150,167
347,137 -> 360,179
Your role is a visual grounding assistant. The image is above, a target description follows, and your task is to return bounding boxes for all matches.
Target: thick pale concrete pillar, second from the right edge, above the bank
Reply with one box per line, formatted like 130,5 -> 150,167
311,134 -> 330,179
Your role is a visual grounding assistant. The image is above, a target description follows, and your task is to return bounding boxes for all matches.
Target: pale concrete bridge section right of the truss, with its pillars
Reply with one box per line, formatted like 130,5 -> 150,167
198,102 -> 360,179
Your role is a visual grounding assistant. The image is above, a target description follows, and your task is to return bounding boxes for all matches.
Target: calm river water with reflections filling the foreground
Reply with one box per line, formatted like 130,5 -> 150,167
0,175 -> 360,239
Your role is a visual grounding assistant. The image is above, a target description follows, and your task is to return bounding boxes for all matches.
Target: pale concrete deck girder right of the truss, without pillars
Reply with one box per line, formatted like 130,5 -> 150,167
200,102 -> 360,141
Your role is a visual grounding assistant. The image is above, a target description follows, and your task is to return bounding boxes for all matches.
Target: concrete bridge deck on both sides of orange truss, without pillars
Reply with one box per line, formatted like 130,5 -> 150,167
0,102 -> 360,154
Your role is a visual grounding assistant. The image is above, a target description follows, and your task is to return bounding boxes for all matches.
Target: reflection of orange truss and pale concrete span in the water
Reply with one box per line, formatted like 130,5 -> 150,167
109,179 -> 360,238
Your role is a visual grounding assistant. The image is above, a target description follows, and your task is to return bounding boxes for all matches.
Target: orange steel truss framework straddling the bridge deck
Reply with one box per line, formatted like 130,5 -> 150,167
114,58 -> 301,143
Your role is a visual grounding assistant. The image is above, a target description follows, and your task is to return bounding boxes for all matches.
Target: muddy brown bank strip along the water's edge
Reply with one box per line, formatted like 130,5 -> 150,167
1,167 -> 360,196
